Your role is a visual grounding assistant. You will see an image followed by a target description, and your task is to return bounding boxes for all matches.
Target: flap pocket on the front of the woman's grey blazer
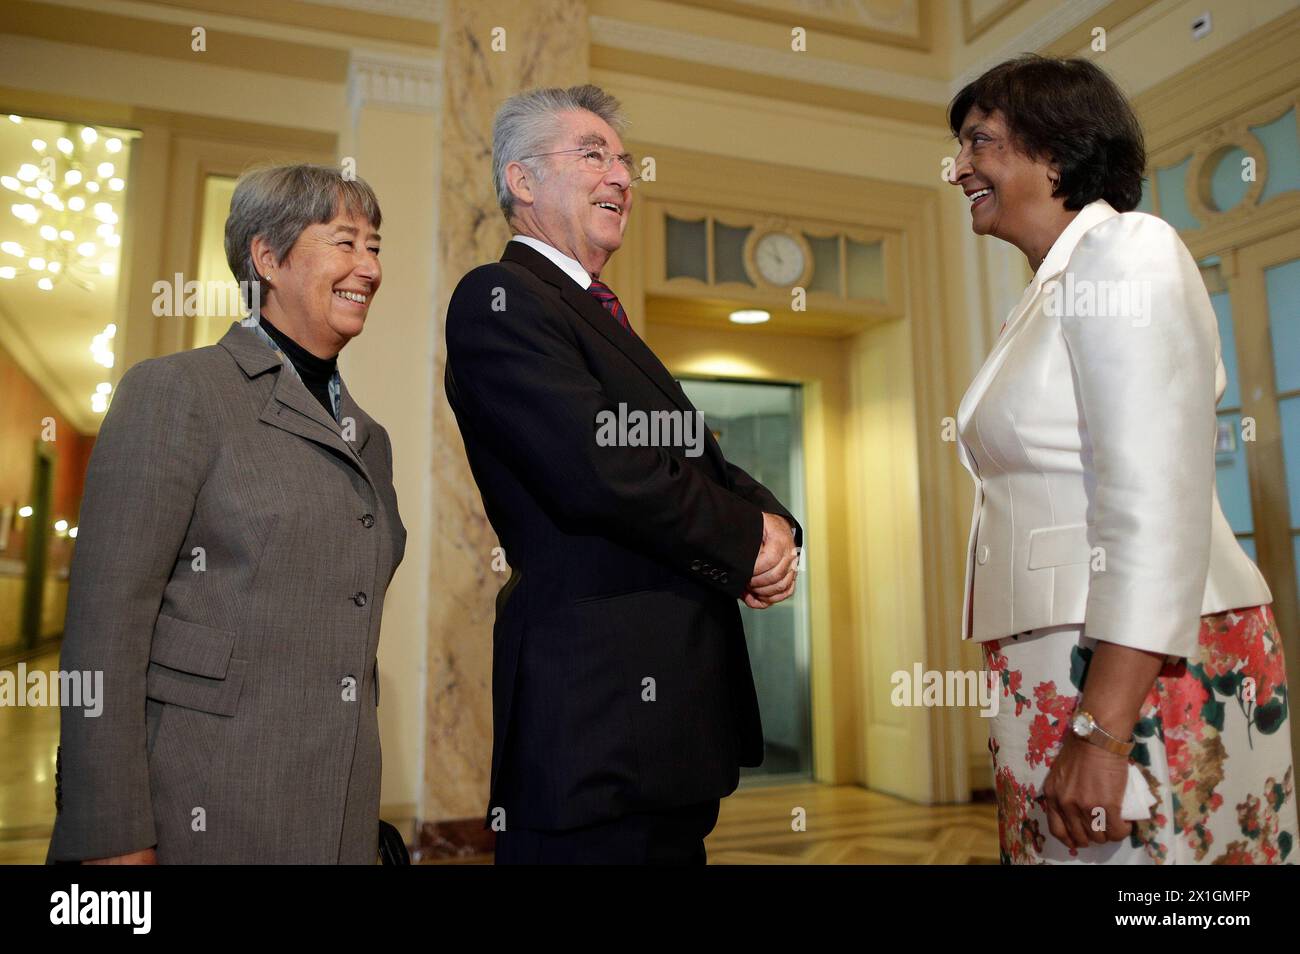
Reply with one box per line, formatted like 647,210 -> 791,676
146,615 -> 246,716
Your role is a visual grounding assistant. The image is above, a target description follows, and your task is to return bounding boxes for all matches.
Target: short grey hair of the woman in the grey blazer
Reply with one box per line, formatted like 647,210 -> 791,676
226,162 -> 384,311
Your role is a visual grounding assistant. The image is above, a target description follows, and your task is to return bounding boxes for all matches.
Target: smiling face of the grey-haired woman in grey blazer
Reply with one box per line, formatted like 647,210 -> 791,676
254,209 -> 382,357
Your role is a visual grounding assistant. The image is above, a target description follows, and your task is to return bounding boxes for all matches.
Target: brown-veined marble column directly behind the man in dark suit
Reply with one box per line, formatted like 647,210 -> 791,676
423,0 -> 589,823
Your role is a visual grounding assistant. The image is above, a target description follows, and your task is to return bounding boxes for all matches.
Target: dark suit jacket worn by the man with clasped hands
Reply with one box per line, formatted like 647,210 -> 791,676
446,242 -> 793,829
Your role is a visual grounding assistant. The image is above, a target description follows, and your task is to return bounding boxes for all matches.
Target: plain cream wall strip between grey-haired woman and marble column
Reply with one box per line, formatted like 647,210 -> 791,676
341,103 -> 442,821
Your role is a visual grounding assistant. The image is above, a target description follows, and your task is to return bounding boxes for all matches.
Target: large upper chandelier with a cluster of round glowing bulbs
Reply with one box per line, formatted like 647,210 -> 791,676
0,116 -> 126,291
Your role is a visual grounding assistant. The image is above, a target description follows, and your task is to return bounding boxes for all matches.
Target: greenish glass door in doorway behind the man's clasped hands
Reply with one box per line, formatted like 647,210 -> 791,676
681,380 -> 813,781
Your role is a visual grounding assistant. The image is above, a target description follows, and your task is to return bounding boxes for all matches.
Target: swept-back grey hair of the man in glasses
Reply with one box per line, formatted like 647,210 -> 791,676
491,84 -> 628,222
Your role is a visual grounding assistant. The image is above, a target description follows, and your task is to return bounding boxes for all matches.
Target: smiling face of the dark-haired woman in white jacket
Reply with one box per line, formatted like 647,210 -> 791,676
953,107 -> 1065,250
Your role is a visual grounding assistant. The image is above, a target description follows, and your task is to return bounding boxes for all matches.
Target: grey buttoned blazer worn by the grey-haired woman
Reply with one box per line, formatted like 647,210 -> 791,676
49,324 -> 406,864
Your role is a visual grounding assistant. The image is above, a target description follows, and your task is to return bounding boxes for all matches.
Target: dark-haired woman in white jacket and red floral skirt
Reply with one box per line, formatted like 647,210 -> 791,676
949,56 -> 1296,864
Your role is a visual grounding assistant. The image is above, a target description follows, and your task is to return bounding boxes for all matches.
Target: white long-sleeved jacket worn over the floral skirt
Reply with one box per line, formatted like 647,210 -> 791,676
957,200 -> 1273,656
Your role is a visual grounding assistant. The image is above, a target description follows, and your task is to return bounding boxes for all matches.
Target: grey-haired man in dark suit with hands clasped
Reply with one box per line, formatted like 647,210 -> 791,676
446,86 -> 801,863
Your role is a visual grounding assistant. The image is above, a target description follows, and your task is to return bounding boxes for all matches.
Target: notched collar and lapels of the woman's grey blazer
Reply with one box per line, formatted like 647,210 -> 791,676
218,322 -> 371,481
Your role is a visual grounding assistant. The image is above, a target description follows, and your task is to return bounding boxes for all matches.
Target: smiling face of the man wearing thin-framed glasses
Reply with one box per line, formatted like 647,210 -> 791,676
506,109 -> 632,276
